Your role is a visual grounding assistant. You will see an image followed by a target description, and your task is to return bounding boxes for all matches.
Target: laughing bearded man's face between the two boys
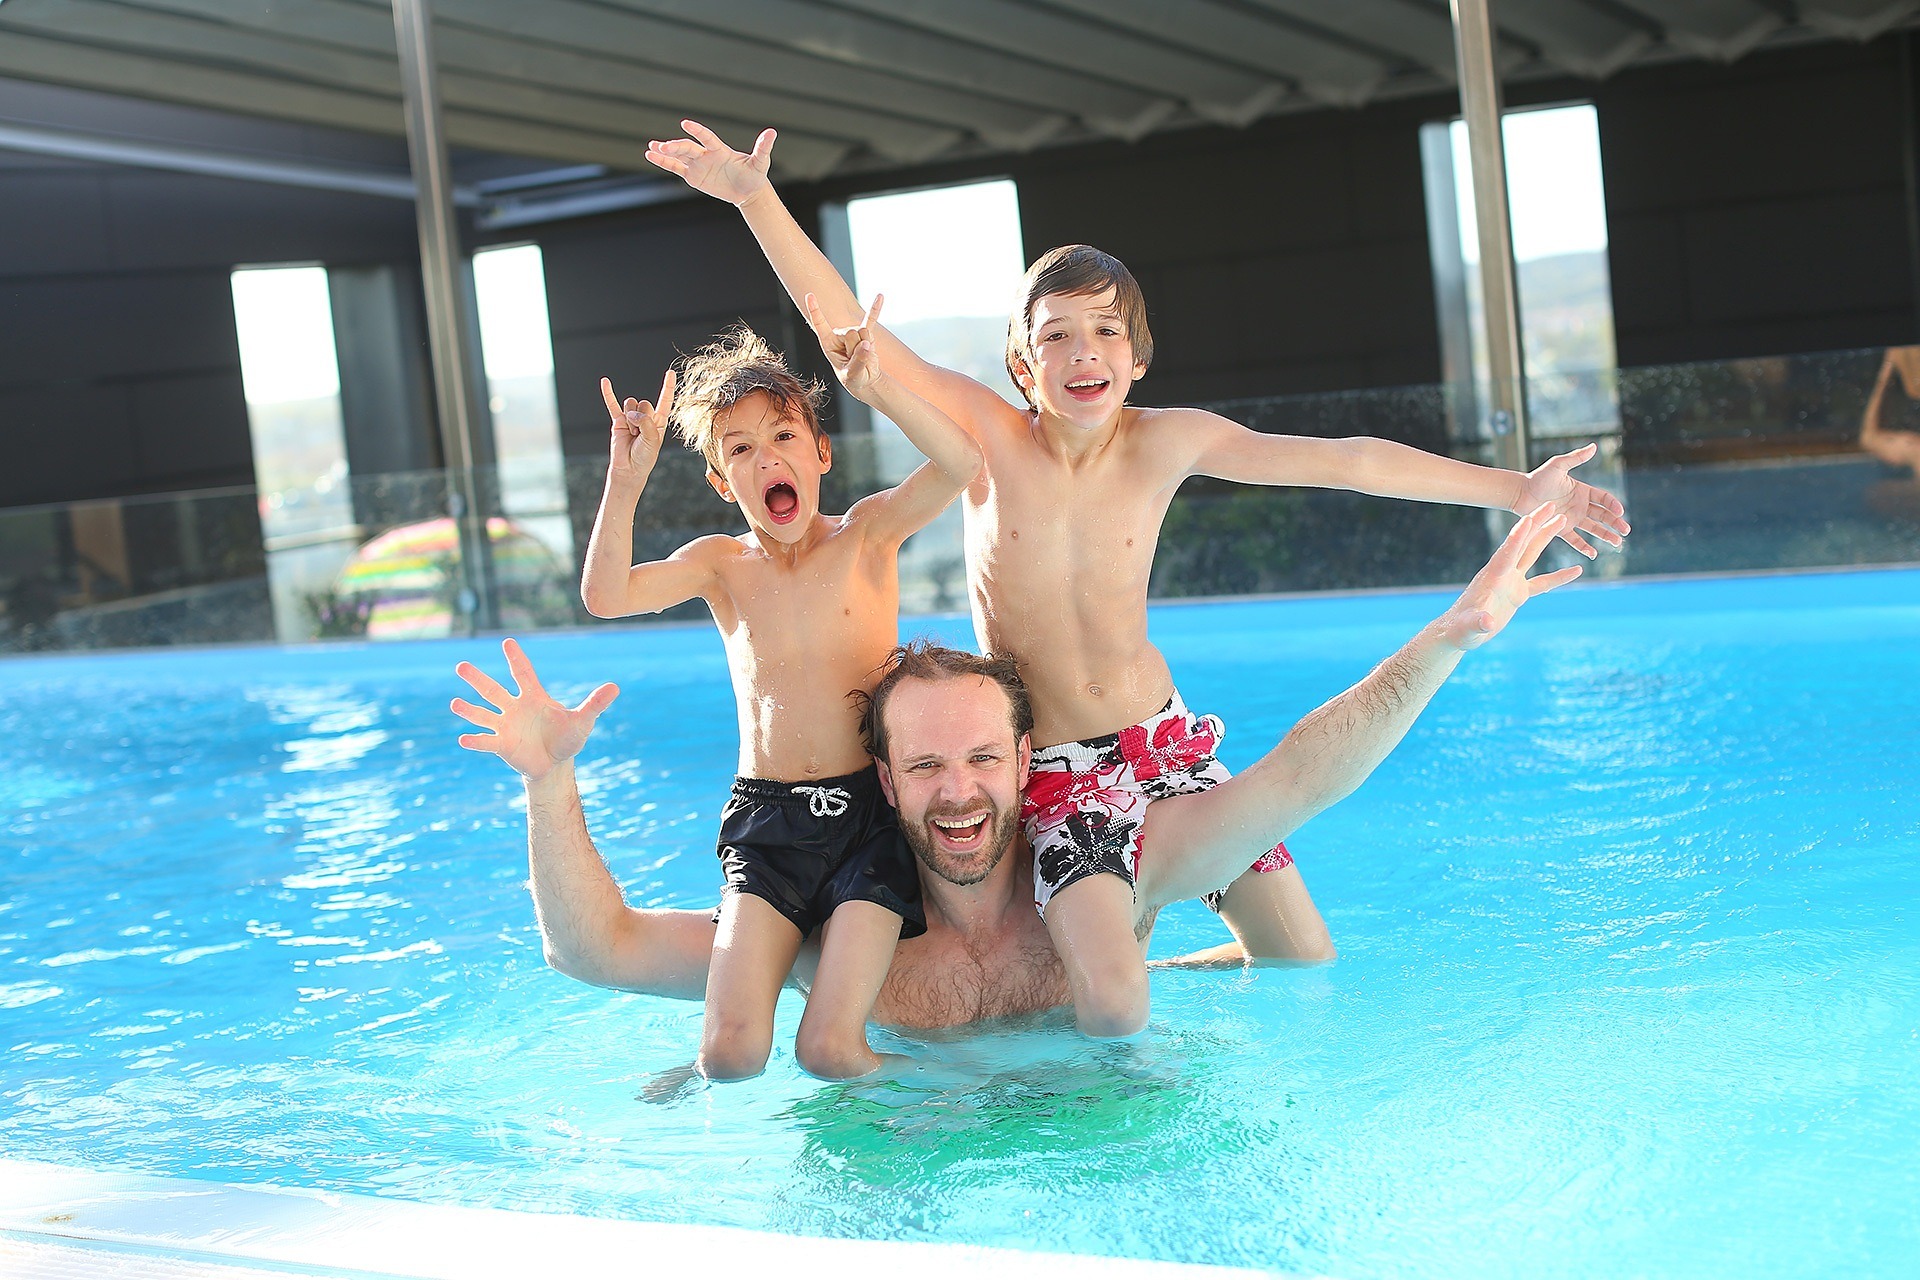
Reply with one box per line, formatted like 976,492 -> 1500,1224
879,676 -> 1029,885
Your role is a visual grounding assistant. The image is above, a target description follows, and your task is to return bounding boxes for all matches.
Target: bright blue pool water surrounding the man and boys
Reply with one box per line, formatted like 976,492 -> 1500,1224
0,572 -> 1920,1276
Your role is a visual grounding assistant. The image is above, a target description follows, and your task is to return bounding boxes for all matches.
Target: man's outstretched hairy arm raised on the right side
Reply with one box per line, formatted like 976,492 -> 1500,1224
1139,507 -> 1580,908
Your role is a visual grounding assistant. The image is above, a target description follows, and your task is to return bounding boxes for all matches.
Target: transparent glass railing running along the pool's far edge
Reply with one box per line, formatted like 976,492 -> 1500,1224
0,349 -> 1920,651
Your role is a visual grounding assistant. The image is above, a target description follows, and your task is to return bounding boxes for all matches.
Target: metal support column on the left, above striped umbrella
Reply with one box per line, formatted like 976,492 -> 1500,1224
394,0 -> 499,633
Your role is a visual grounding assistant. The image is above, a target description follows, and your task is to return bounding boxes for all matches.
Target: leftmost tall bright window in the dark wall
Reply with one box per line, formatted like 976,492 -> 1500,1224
232,267 -> 357,641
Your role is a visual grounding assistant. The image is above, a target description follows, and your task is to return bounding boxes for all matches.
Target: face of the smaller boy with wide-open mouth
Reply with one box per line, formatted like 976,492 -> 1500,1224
707,391 -> 833,543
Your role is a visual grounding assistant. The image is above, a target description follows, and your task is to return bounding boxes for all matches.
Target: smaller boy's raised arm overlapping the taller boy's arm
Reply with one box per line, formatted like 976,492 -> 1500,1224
806,294 -> 983,547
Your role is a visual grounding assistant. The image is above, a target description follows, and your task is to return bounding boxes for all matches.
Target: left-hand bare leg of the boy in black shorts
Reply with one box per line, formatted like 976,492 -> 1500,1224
697,892 -> 803,1080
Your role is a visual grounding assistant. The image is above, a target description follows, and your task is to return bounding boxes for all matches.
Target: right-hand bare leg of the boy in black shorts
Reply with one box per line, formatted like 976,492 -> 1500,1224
793,900 -> 900,1080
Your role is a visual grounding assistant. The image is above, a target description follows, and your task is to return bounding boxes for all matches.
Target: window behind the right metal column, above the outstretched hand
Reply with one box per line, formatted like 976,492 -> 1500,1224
1421,104 -> 1620,438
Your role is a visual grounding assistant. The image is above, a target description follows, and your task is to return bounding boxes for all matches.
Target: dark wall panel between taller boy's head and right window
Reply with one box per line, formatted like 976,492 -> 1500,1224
1012,104 -> 1440,403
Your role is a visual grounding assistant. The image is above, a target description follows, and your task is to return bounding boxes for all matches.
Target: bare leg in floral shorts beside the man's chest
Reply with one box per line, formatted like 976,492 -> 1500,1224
1044,871 -> 1148,1040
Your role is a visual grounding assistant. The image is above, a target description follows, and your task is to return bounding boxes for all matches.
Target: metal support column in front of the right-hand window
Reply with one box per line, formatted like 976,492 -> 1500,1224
1452,0 -> 1530,470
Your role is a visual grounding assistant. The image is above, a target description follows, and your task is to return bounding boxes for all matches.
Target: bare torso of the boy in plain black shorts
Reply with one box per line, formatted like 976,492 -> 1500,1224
693,514 -> 900,783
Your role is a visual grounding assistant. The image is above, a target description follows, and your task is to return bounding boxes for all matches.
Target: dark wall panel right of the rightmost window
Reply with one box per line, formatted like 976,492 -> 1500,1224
1594,35 -> 1920,365
